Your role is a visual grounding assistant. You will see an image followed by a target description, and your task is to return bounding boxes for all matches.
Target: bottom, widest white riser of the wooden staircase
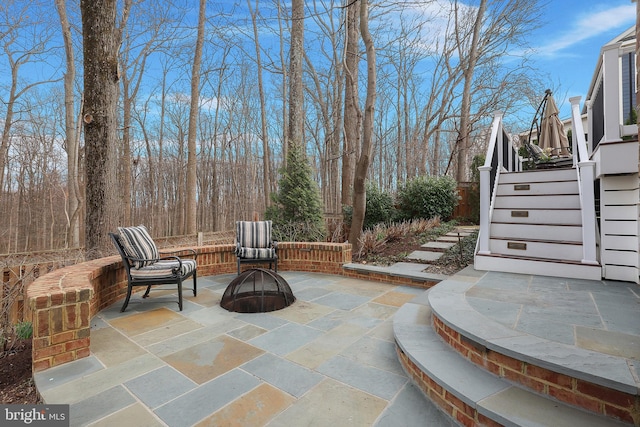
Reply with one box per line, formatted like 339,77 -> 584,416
474,255 -> 602,280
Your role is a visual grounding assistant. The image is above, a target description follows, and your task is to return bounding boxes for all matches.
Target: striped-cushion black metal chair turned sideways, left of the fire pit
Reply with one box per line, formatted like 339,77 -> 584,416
109,226 -> 197,312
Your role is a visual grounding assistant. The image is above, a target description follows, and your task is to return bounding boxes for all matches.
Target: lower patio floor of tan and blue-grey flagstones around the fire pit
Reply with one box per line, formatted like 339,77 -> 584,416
36,272 -> 454,427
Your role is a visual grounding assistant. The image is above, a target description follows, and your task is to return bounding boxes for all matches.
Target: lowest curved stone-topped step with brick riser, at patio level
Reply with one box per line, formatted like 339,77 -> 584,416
393,298 -> 625,427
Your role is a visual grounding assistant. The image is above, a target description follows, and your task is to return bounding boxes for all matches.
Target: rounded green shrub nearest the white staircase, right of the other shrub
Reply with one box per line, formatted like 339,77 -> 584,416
397,176 -> 459,220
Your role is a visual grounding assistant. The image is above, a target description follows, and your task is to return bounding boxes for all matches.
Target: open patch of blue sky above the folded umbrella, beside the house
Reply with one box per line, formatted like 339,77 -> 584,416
530,0 -> 636,118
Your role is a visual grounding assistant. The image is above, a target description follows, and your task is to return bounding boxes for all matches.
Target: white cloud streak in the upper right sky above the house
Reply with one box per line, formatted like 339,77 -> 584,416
536,4 -> 636,56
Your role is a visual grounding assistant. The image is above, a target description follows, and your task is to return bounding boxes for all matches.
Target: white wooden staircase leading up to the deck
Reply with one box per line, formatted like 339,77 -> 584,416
475,168 -> 602,280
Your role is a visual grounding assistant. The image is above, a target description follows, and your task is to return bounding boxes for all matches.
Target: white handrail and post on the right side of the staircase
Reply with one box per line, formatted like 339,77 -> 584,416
569,96 -> 598,264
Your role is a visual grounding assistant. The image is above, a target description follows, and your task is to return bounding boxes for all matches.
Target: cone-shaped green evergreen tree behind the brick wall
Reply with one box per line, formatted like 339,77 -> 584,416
266,144 -> 326,241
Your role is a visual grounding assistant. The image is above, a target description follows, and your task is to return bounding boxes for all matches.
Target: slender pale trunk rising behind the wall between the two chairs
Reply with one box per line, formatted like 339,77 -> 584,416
185,0 -> 207,234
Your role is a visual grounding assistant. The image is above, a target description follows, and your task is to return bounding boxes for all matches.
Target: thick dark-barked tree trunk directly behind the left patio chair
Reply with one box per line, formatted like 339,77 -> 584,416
80,0 -> 127,259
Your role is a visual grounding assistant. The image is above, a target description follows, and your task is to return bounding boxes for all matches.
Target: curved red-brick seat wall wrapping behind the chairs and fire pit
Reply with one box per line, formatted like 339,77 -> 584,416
26,242 -> 351,371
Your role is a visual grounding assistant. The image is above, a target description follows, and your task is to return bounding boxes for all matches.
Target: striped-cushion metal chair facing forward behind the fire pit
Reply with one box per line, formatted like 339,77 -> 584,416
235,221 -> 278,274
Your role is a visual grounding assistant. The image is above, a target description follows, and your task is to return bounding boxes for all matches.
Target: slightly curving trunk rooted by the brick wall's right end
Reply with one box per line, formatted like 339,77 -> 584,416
349,0 -> 376,252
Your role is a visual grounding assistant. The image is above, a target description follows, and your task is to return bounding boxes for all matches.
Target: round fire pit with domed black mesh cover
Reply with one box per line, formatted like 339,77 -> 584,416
220,268 -> 296,313
